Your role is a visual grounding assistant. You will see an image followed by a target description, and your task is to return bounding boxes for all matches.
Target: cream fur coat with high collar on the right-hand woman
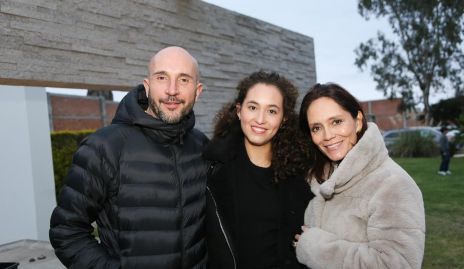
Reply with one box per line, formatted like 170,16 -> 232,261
296,123 -> 425,269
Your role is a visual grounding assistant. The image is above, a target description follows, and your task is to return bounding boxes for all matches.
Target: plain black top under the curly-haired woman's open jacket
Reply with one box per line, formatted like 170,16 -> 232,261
236,143 -> 282,268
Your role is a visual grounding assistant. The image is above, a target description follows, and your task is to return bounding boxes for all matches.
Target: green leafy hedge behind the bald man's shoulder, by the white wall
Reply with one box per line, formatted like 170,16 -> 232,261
51,130 -> 94,196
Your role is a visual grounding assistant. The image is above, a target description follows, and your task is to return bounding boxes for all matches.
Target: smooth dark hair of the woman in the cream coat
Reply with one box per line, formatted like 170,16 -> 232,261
300,83 -> 367,184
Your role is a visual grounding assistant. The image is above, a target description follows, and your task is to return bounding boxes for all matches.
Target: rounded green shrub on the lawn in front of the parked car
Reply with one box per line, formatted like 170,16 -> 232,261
390,132 -> 440,157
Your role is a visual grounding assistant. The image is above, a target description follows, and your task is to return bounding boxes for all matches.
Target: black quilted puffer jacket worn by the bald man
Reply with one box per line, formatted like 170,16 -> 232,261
50,85 -> 207,269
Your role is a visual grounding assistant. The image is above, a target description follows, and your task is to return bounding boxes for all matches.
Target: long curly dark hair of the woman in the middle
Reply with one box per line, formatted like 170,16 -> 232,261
213,71 -> 311,182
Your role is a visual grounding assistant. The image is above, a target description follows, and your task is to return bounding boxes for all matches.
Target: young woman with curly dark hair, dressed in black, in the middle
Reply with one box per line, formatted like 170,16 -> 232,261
204,71 -> 312,269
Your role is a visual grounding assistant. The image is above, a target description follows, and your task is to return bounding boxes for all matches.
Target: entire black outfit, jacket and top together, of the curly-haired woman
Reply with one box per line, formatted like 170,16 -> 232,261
203,127 -> 313,269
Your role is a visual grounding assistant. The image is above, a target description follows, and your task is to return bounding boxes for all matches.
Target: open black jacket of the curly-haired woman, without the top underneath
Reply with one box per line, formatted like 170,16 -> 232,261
203,129 -> 313,269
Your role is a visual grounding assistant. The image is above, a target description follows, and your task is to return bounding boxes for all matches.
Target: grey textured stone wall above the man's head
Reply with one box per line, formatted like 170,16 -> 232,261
0,0 -> 316,134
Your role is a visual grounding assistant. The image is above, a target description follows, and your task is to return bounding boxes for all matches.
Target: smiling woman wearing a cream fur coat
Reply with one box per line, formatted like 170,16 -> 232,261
295,84 -> 425,269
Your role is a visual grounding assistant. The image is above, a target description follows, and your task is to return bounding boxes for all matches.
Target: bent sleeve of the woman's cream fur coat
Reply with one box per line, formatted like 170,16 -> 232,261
296,174 -> 425,269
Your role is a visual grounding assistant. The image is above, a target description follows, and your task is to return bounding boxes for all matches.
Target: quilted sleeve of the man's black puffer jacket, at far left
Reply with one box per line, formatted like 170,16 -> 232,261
49,134 -> 121,269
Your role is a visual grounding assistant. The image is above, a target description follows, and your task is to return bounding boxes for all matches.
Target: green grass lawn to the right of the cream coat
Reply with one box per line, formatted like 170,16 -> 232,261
395,157 -> 464,269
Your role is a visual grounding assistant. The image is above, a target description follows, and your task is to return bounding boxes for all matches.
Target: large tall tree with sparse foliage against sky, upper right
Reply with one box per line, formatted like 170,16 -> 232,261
355,0 -> 464,124
